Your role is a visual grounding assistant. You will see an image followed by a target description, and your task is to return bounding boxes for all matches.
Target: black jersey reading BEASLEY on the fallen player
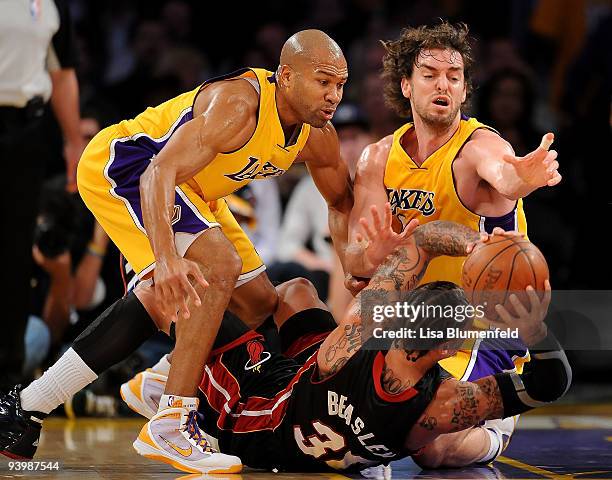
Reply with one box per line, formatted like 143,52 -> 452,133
274,349 -> 447,470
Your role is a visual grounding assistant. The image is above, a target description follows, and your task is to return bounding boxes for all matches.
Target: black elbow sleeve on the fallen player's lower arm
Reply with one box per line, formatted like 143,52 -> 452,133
495,331 -> 572,418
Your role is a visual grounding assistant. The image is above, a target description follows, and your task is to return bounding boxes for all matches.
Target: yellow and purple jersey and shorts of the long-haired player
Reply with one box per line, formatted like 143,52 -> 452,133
384,116 -> 529,381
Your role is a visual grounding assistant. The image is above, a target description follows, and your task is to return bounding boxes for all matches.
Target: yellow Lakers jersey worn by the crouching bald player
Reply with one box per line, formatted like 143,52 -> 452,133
113,68 -> 310,201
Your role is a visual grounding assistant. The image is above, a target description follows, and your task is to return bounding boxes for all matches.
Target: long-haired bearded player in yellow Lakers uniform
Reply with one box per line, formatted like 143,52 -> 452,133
346,22 -> 561,464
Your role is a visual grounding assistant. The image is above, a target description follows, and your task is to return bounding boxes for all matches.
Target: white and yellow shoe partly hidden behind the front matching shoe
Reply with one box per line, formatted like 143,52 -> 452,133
119,369 -> 168,419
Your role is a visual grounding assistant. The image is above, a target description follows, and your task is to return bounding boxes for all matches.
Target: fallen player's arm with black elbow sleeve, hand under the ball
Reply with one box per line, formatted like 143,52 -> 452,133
407,287 -> 572,456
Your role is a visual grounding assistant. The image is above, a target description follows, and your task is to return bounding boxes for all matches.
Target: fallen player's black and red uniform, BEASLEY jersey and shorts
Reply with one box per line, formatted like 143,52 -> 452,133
199,316 -> 449,471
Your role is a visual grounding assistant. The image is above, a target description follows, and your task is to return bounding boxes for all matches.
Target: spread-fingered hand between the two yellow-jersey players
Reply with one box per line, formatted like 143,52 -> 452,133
355,202 -> 419,270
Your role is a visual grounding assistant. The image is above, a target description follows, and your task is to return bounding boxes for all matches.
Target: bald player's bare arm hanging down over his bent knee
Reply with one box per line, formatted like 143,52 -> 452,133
140,81 -> 258,321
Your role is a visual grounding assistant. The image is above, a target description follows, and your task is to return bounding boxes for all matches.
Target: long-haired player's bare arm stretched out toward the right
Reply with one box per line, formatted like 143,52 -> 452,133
460,129 -> 561,200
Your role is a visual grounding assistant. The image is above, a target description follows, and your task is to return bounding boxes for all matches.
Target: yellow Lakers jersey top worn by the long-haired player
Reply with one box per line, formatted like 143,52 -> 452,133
384,117 -> 527,285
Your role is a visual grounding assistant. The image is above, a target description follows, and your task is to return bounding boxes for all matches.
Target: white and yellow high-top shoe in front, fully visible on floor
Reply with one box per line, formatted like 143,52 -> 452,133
134,399 -> 242,474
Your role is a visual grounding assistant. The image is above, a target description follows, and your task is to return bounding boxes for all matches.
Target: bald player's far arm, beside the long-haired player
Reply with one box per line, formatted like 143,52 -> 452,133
298,123 -> 353,271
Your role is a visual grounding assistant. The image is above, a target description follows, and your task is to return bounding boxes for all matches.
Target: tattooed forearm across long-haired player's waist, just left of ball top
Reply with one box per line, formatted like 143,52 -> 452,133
414,220 -> 480,257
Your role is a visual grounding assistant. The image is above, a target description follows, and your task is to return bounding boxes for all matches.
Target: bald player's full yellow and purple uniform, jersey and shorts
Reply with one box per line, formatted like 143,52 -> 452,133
77,68 -> 310,284
